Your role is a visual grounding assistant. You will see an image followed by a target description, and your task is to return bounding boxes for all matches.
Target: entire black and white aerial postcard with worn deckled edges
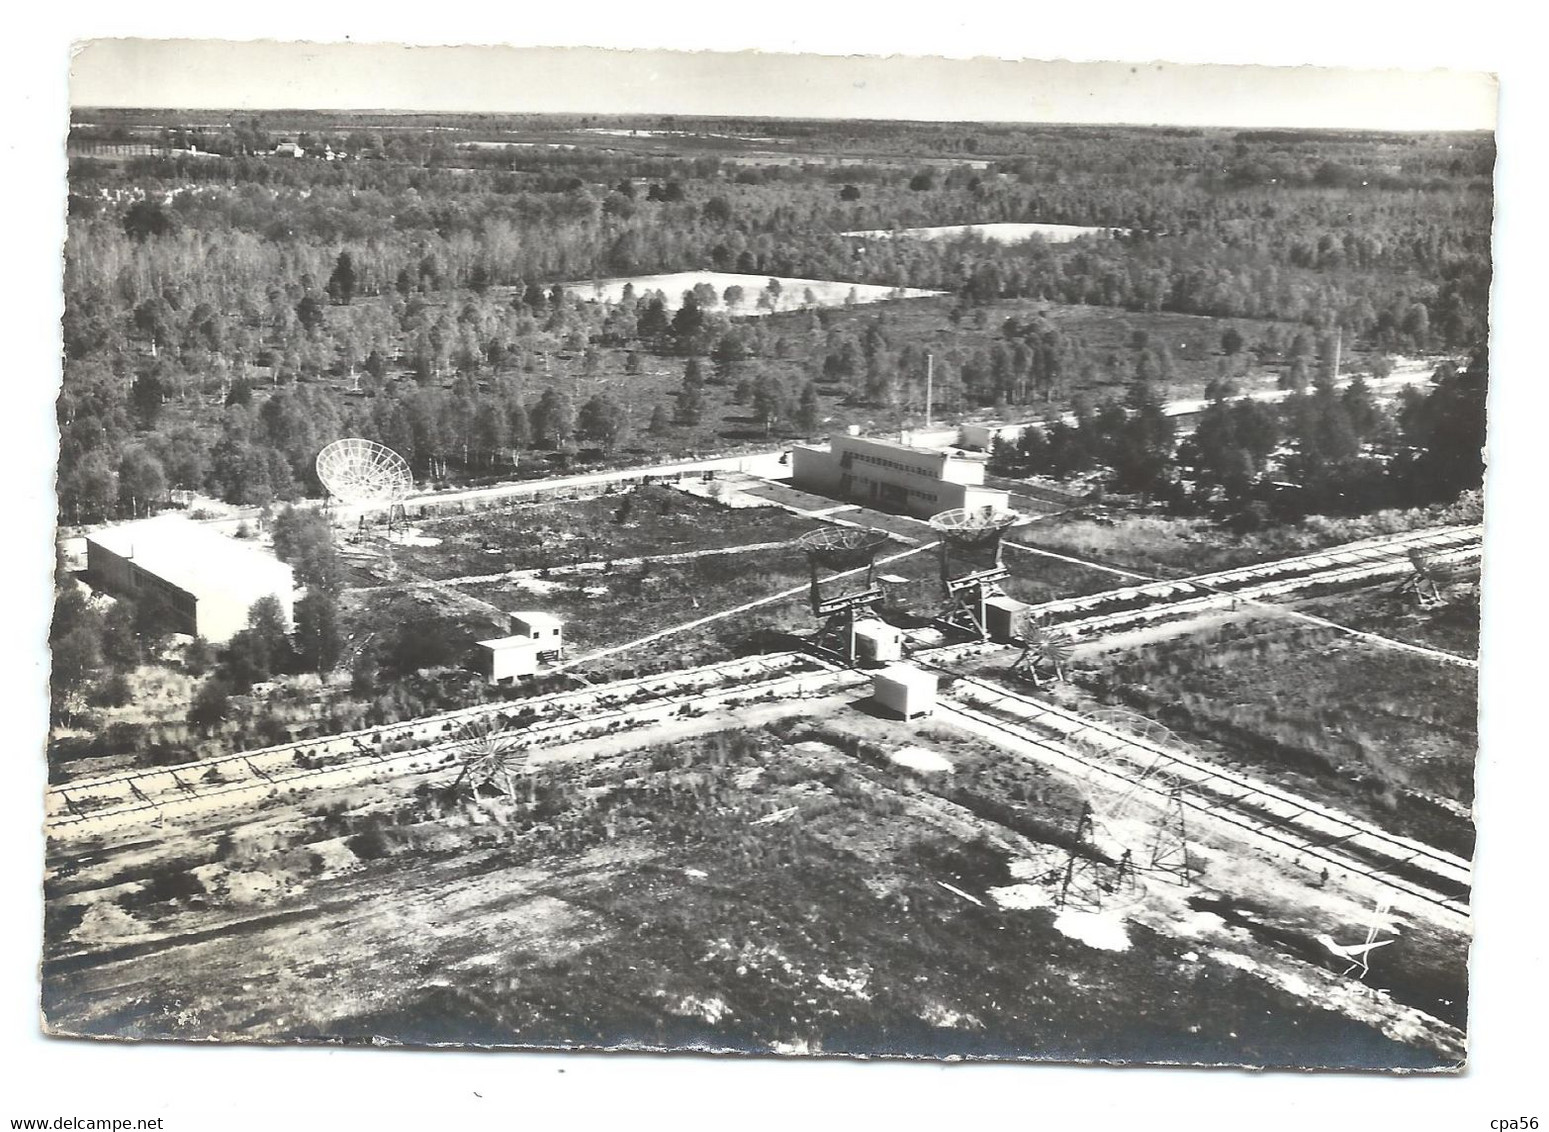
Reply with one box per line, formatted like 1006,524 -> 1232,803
5,13 -> 1549,1127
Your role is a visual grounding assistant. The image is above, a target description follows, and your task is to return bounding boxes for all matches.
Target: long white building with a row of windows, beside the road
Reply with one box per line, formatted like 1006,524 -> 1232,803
792,435 -> 1010,519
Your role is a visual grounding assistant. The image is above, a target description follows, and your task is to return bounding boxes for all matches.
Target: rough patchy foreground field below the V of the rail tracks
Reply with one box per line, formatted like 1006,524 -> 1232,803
43,705 -> 1461,1069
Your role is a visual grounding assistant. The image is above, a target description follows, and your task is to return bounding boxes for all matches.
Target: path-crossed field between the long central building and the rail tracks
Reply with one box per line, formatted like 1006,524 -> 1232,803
345,485 -> 1133,675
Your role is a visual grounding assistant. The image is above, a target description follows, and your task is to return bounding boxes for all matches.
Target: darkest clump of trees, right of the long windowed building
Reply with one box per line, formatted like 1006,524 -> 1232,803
990,350 -> 1489,522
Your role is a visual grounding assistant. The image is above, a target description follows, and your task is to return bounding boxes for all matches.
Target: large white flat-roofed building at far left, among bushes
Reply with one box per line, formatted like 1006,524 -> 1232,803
87,514 -> 296,644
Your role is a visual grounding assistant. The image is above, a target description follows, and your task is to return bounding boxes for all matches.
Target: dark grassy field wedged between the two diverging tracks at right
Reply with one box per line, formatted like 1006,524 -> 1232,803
1080,613 -> 1478,856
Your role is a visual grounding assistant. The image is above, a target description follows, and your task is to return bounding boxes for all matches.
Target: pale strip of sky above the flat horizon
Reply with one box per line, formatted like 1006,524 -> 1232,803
70,39 -> 1496,130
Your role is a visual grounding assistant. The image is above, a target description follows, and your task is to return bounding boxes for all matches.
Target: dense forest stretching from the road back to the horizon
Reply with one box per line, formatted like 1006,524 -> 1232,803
59,113 -> 1493,522
